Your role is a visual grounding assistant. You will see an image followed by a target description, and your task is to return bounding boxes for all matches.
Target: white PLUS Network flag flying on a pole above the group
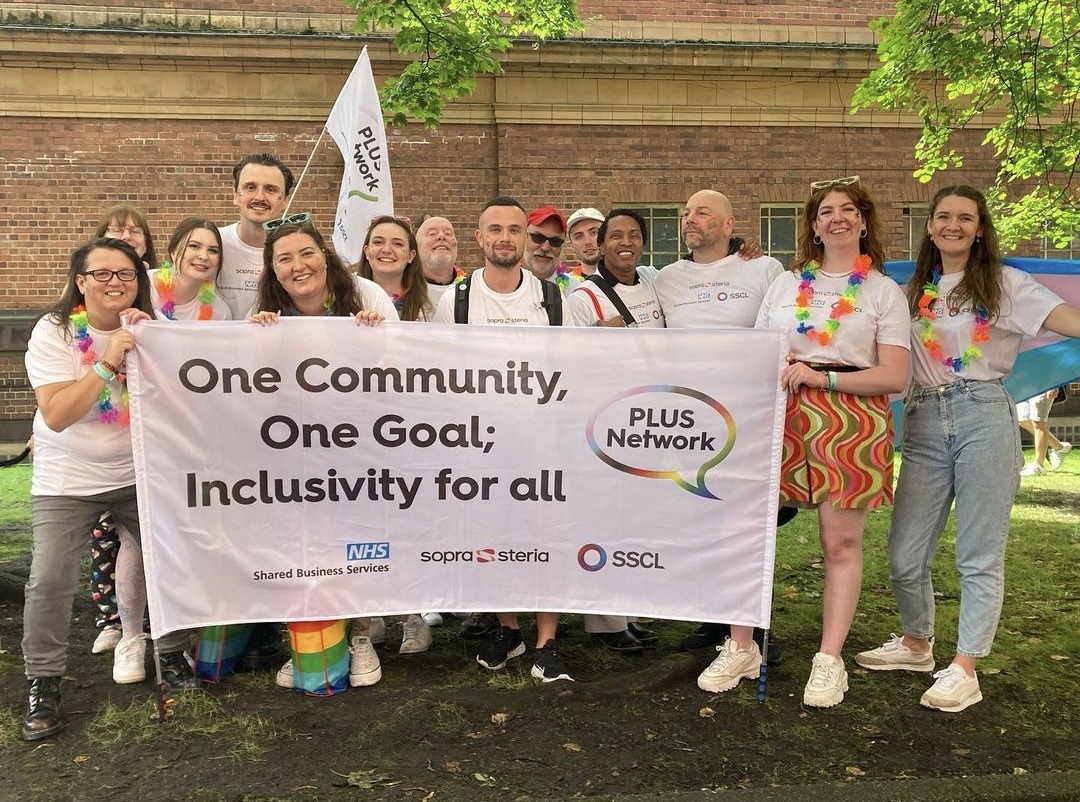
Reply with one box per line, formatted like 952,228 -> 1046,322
326,47 -> 394,264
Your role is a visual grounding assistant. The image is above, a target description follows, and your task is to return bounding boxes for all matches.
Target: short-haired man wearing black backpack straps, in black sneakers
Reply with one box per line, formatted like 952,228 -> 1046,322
435,196 -> 571,682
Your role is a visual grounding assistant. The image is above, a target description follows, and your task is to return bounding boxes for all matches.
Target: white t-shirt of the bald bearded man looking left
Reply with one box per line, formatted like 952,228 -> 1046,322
656,254 -> 784,328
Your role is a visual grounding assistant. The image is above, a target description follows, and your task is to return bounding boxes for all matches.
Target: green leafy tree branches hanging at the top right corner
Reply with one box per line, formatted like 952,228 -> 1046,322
852,0 -> 1080,247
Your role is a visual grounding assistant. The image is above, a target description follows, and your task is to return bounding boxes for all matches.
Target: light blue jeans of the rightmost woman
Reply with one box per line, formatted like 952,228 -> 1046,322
889,380 -> 1024,657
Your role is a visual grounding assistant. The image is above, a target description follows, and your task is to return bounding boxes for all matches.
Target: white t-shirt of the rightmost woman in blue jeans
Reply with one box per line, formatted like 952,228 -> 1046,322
912,266 -> 1064,388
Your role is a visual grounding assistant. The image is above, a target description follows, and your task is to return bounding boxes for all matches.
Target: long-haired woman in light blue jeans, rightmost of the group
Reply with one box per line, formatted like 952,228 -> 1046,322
855,185 -> 1080,712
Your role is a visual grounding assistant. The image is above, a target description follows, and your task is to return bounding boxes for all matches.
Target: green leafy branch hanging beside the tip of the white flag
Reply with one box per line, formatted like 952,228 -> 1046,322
346,0 -> 584,128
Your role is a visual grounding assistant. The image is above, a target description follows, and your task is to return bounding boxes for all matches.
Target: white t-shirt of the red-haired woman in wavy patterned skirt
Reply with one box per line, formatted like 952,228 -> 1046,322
756,270 -> 912,368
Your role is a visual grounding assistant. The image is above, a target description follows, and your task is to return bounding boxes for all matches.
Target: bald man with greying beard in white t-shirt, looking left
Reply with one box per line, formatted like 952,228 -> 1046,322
653,189 -> 794,664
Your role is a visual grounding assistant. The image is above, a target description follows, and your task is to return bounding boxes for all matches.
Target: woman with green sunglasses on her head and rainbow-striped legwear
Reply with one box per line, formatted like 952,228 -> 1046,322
252,213 -> 397,696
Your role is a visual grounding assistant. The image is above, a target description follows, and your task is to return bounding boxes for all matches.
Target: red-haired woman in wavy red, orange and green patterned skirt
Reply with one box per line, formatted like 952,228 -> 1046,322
751,179 -> 910,707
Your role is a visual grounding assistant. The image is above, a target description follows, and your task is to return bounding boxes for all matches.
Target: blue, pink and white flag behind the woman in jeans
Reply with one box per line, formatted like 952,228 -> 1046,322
885,257 -> 1080,403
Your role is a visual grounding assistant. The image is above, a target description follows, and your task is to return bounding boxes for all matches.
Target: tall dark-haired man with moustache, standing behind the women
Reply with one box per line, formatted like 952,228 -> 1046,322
217,153 -> 293,321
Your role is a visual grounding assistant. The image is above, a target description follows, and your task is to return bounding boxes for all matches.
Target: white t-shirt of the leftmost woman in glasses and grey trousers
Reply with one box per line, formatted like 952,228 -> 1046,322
26,315 -> 135,497
